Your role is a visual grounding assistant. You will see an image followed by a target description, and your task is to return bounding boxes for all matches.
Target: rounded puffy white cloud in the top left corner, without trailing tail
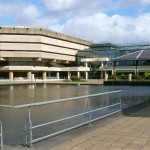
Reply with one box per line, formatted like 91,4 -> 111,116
0,2 -> 40,25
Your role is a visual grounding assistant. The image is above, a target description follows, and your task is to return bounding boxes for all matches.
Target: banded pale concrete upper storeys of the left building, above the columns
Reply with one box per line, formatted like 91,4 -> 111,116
0,27 -> 92,61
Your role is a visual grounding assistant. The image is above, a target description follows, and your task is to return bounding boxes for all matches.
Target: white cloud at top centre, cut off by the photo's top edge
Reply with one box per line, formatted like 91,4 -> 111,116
42,0 -> 112,19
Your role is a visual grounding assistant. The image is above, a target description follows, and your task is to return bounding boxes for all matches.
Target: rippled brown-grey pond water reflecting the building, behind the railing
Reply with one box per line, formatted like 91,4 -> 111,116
0,84 -> 150,145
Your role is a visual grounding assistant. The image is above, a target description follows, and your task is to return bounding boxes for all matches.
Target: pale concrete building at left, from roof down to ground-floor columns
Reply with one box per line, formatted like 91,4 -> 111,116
0,27 -> 93,80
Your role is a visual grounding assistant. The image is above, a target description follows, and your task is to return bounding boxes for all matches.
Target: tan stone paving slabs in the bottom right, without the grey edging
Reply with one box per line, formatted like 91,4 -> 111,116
49,103 -> 150,150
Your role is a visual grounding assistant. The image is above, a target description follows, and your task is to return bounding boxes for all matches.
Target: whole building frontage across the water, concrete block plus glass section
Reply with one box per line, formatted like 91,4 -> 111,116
0,27 -> 150,81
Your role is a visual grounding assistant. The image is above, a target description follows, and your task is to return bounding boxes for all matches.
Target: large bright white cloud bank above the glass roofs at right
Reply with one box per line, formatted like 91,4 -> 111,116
50,13 -> 150,43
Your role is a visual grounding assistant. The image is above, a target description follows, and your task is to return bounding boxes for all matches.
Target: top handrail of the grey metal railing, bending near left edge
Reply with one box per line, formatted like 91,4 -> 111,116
0,90 -> 122,108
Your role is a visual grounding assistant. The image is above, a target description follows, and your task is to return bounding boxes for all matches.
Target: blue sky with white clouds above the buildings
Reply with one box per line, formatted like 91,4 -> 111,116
0,0 -> 150,44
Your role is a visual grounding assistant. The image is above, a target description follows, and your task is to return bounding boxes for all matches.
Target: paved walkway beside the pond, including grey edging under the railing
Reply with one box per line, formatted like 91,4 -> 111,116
4,102 -> 150,150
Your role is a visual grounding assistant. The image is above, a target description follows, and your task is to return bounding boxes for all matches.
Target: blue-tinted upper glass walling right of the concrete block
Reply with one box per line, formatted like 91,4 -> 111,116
77,43 -> 150,66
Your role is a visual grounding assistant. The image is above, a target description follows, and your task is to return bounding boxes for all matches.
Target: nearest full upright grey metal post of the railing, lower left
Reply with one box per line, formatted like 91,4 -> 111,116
28,107 -> 33,148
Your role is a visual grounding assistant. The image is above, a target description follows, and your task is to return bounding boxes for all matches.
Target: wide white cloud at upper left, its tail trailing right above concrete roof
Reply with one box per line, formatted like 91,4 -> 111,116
0,0 -> 58,28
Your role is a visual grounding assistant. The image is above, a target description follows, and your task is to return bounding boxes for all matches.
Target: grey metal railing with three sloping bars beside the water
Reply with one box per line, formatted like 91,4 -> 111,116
0,90 -> 121,147
